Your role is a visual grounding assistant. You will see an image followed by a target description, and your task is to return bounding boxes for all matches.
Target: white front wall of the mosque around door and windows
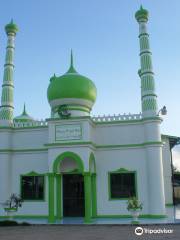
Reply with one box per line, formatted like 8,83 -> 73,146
0,117 -> 176,221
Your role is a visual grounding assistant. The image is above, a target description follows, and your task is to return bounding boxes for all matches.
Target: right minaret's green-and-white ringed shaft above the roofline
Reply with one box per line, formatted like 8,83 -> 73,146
135,6 -> 157,118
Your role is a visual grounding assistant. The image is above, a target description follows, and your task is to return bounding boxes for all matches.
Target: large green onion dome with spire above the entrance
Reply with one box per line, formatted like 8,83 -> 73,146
47,52 -> 97,116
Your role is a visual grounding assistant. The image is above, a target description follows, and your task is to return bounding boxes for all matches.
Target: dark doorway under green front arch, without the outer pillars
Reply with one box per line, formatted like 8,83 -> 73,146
53,152 -> 85,219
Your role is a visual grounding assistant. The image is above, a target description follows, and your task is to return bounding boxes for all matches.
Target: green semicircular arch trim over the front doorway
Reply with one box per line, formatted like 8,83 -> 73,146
53,152 -> 84,173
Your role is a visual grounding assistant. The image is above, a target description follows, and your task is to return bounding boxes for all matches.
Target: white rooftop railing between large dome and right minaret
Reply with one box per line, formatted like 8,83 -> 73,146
92,113 -> 142,122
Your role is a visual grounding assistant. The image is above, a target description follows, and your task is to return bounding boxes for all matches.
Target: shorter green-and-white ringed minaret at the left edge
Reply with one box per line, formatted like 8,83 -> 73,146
0,20 -> 18,126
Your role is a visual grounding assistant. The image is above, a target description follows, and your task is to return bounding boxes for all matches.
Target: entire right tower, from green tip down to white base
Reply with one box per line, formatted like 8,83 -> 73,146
135,6 -> 165,217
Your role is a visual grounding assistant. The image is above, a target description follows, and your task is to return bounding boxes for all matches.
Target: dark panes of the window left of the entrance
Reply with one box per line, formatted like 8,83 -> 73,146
21,176 -> 44,200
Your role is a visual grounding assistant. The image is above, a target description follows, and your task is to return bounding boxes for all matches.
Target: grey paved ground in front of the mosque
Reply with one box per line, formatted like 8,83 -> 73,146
0,224 -> 180,240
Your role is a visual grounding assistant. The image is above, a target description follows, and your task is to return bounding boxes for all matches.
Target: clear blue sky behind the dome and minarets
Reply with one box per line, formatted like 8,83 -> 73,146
0,0 -> 180,167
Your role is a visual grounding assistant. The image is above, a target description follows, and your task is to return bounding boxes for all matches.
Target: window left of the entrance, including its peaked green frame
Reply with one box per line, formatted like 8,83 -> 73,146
20,172 -> 46,202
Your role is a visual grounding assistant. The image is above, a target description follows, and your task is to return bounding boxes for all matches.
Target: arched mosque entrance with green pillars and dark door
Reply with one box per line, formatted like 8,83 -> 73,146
48,152 -> 92,223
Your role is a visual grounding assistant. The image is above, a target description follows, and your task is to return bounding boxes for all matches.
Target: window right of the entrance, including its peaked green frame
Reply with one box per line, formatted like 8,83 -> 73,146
108,168 -> 138,200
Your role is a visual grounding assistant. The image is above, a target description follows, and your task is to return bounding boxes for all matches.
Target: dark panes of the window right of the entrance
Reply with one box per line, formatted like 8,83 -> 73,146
109,172 -> 136,199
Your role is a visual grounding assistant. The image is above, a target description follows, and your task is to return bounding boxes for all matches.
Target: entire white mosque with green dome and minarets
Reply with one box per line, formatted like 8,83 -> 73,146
0,7 -> 180,223
